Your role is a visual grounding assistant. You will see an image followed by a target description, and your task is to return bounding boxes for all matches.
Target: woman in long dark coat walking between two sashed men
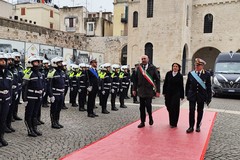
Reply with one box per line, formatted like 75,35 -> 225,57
163,63 -> 184,128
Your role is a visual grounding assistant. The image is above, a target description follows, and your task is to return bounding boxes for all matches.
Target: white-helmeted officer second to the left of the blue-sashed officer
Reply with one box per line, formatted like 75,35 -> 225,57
69,64 -> 79,107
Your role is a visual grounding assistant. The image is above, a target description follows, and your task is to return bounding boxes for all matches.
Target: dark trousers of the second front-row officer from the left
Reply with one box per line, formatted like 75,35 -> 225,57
24,98 -> 42,128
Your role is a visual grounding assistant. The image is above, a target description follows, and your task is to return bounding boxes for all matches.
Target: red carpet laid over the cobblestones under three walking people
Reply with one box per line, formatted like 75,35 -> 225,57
61,109 -> 216,160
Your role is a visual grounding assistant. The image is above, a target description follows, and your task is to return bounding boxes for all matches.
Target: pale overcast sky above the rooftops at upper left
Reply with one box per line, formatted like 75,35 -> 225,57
5,0 -> 113,12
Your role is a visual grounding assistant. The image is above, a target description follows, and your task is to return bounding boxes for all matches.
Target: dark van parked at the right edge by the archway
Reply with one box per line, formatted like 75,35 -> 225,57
212,52 -> 240,96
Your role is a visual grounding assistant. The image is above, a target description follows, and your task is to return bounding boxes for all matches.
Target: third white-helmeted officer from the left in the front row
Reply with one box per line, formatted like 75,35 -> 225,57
48,57 -> 65,129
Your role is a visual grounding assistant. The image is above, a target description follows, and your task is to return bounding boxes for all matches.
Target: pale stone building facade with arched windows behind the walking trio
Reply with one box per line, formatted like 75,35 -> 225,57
127,0 -> 240,76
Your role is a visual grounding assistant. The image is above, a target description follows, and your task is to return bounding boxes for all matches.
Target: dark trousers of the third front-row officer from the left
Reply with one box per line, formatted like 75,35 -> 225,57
50,94 -> 64,120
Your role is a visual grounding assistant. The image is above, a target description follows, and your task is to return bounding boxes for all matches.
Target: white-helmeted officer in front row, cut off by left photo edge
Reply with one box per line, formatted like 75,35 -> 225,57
0,52 -> 13,147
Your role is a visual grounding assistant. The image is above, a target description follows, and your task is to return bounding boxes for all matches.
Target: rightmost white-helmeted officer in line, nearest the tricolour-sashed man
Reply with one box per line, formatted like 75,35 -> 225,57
119,65 -> 129,108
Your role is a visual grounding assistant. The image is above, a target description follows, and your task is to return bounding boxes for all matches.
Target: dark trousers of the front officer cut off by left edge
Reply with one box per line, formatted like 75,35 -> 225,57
0,100 -> 10,135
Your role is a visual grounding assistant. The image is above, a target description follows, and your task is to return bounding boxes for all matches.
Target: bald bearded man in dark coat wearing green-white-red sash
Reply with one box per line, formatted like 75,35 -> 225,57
133,55 -> 160,128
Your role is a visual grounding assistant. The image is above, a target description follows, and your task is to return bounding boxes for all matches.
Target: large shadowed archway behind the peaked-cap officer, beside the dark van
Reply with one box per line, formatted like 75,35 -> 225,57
192,47 -> 221,70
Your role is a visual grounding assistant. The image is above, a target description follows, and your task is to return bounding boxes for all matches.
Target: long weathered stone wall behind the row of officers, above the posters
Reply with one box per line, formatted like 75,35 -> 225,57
0,18 -> 127,63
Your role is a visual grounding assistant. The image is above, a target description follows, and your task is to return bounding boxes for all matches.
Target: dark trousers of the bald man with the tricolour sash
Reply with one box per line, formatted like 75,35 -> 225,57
139,97 -> 152,123
